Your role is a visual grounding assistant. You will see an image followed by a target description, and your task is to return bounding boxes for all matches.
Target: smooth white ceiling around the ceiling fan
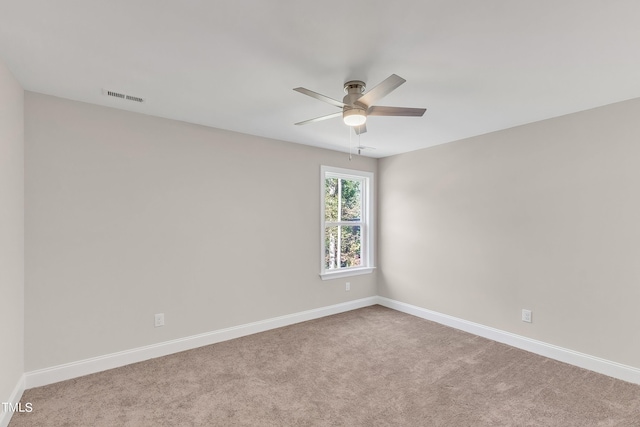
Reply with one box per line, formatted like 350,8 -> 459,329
0,0 -> 640,157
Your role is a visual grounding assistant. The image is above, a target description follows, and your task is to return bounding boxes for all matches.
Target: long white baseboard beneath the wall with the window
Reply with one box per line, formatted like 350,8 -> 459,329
25,297 -> 378,392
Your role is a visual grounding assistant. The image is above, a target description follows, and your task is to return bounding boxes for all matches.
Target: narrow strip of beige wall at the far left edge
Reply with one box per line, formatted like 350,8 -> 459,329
0,61 -> 24,402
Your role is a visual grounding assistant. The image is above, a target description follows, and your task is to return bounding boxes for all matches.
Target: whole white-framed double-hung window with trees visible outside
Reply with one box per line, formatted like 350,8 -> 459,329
320,166 -> 374,280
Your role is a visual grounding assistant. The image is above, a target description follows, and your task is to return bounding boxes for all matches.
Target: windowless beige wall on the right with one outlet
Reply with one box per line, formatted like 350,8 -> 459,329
378,99 -> 640,367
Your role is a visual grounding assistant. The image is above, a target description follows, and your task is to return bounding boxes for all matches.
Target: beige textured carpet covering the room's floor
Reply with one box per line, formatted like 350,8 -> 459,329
10,306 -> 640,427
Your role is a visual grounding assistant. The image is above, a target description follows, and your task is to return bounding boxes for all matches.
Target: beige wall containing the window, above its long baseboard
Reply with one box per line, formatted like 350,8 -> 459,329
25,92 -> 377,371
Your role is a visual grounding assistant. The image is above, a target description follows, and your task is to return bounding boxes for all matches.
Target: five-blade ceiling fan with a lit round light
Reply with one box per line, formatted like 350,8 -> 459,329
293,74 -> 427,135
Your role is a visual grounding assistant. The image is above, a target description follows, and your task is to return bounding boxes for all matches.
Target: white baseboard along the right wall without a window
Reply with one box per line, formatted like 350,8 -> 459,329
377,296 -> 640,384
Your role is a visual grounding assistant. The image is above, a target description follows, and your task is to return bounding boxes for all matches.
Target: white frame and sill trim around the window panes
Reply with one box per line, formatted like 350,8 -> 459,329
320,166 -> 375,280
